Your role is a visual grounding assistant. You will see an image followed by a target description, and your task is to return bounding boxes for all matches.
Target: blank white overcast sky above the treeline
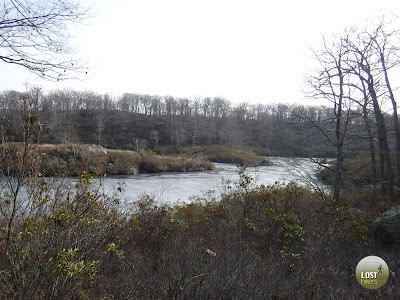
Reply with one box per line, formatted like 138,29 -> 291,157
0,0 -> 400,103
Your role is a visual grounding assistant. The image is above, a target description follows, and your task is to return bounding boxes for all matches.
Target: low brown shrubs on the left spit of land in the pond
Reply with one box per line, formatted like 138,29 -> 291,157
0,143 -> 214,176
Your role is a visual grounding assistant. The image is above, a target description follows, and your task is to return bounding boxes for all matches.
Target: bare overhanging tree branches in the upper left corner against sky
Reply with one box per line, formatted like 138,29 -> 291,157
0,0 -> 88,81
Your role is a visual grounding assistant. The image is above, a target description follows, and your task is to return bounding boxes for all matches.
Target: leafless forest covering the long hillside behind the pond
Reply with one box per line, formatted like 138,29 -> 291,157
0,88 -> 390,157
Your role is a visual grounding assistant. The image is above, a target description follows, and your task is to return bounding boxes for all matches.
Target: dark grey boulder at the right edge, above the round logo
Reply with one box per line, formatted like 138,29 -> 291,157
372,206 -> 400,248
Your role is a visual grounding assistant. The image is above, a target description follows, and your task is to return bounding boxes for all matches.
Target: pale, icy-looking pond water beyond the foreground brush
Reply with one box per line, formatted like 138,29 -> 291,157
99,157 -> 324,203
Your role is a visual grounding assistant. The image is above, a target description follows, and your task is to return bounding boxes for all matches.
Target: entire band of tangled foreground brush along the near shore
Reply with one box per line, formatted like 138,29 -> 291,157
0,165 -> 400,299
